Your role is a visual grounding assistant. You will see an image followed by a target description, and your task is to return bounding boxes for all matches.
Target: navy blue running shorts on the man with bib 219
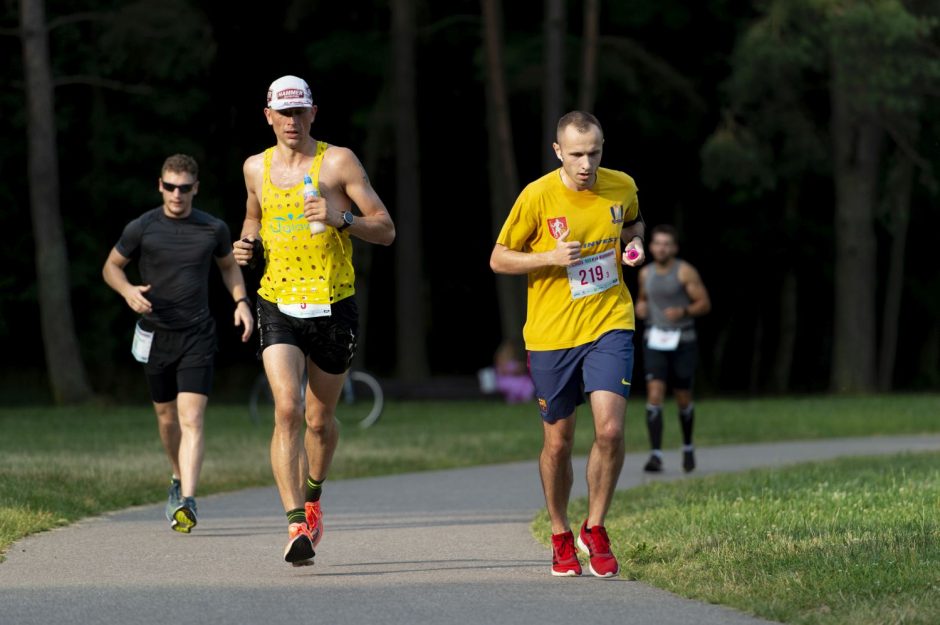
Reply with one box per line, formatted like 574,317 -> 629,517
529,330 -> 633,423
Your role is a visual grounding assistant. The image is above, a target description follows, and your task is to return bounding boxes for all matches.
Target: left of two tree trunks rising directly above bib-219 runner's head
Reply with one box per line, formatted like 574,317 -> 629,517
541,0 -> 565,172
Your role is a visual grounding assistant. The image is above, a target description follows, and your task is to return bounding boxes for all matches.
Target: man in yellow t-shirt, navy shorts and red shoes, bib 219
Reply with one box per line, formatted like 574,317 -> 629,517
490,111 -> 645,577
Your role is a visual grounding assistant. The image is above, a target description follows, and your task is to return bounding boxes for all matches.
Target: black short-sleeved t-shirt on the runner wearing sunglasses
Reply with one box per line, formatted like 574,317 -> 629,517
115,206 -> 232,330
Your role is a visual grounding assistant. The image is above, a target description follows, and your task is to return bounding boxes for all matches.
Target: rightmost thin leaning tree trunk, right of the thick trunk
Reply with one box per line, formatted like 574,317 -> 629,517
878,150 -> 914,391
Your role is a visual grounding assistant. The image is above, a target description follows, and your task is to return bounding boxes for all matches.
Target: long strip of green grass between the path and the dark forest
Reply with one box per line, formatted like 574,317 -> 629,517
0,395 -> 940,553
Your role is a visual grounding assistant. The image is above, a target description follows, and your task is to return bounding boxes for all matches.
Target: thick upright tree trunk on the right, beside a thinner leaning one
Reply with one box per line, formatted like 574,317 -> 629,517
830,61 -> 884,393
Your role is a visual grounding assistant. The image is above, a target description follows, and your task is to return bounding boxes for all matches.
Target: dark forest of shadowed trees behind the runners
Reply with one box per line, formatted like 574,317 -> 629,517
0,0 -> 940,403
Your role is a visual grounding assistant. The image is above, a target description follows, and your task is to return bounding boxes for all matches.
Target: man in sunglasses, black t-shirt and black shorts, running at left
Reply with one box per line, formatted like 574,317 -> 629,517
102,154 -> 254,533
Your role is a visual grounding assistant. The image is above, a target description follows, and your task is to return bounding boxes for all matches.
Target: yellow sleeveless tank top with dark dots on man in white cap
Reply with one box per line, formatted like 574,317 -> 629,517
258,141 -> 356,304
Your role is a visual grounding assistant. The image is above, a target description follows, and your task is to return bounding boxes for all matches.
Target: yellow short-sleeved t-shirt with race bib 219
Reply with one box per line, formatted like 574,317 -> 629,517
496,168 -> 639,351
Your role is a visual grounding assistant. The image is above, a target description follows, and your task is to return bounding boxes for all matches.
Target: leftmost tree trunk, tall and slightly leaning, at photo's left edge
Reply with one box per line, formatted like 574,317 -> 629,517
20,0 -> 92,404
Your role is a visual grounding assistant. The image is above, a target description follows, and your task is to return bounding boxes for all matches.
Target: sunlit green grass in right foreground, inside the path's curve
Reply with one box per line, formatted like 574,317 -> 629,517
533,453 -> 940,625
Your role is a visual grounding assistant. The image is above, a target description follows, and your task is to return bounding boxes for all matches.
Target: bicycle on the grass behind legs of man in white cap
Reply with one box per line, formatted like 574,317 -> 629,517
248,370 -> 385,429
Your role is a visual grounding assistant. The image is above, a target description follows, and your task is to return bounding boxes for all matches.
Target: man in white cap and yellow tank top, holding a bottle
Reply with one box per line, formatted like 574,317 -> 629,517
233,76 -> 395,566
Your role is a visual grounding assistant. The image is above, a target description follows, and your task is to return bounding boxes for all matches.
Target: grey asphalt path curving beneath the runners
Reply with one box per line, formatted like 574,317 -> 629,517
0,435 -> 940,625
